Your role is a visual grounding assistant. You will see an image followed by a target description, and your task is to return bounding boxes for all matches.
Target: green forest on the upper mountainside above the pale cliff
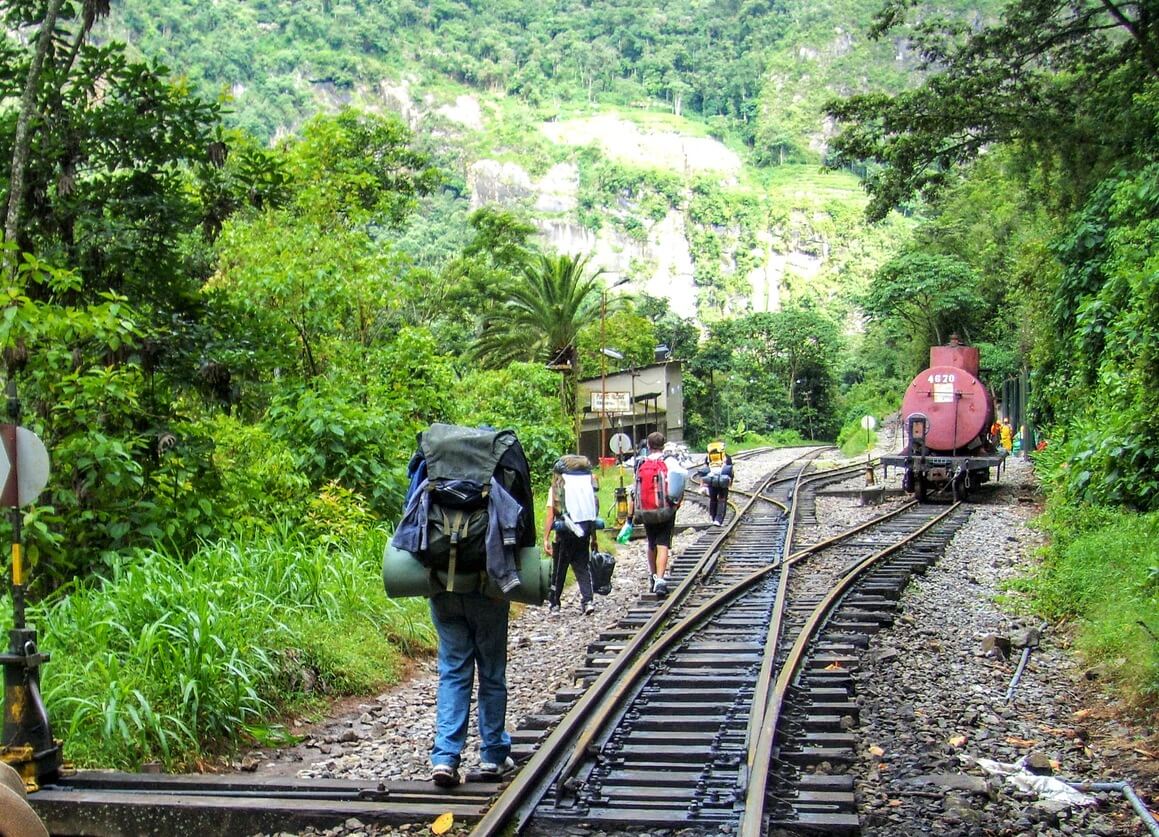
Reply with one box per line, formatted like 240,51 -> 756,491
99,0 -> 977,146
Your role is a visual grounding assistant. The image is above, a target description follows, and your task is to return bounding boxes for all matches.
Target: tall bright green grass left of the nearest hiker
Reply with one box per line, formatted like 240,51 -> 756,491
0,526 -> 433,769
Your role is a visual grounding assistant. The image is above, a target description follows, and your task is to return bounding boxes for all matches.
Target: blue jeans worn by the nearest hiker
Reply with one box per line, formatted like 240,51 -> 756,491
431,592 -> 511,767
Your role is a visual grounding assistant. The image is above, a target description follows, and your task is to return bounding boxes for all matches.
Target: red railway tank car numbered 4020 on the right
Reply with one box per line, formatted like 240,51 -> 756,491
882,336 -> 1005,500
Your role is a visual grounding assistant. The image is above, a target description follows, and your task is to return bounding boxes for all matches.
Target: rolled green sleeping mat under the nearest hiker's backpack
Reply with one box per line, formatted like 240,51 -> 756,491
382,544 -> 552,604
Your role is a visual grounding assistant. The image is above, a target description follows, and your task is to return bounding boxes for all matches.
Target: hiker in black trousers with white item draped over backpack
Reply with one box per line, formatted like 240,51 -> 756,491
544,453 -> 599,617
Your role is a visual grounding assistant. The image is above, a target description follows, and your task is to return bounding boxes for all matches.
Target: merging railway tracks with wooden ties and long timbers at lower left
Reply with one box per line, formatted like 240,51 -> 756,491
22,449 -> 973,836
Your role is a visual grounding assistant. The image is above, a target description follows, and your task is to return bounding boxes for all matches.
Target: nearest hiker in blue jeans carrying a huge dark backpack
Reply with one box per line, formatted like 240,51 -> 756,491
392,424 -> 535,787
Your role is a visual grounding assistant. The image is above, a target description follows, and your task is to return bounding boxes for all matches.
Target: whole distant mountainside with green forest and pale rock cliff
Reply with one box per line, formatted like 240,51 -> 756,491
97,0 -> 972,321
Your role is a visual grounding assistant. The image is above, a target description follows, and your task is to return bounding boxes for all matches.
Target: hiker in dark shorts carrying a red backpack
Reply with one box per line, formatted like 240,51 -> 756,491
628,431 -> 687,598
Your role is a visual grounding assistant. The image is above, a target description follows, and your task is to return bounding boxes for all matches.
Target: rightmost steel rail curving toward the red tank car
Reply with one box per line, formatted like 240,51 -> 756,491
736,503 -> 961,837
